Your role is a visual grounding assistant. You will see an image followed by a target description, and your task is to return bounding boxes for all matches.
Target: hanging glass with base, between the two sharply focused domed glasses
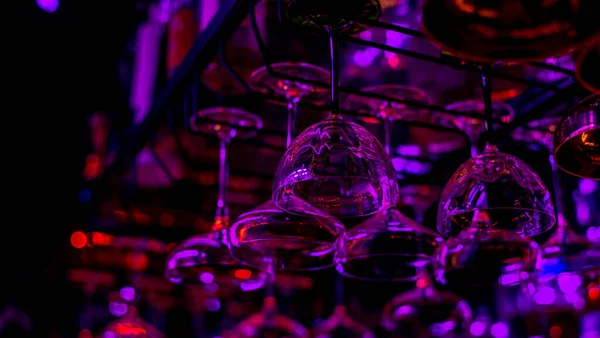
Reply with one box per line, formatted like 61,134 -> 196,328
337,87 -> 443,281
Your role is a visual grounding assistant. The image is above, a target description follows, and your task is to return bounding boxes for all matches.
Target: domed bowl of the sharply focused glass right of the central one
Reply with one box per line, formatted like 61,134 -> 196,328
437,145 -> 556,237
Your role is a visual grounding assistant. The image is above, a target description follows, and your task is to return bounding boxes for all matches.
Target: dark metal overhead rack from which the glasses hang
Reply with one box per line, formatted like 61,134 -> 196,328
106,0 -> 585,180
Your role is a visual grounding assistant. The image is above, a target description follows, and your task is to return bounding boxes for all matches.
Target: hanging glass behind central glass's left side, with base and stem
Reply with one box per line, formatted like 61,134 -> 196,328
229,62 -> 345,271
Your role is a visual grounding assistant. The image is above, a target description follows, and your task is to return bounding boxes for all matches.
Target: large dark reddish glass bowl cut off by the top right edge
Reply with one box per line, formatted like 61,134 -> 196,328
421,0 -> 600,63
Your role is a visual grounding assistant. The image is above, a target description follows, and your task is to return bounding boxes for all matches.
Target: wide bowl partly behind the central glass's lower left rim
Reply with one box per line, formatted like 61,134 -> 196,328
229,197 -> 346,271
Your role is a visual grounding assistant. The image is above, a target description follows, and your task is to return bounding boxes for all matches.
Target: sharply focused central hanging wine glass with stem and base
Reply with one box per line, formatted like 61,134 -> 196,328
273,0 -> 398,218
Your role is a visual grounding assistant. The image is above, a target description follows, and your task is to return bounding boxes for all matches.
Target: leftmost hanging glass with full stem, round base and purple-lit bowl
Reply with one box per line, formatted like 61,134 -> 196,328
165,107 -> 266,291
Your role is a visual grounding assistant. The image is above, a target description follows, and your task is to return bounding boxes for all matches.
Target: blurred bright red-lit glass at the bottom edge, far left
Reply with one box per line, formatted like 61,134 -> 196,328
99,304 -> 167,338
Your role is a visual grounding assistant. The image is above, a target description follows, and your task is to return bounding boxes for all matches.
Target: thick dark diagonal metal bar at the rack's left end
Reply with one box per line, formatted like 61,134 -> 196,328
107,0 -> 251,177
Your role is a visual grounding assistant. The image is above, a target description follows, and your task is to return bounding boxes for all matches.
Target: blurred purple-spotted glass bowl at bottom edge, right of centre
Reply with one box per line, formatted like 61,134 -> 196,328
381,279 -> 472,337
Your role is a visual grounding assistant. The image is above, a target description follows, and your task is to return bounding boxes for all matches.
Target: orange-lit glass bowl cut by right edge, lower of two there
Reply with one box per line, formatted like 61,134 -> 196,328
554,94 -> 600,180
